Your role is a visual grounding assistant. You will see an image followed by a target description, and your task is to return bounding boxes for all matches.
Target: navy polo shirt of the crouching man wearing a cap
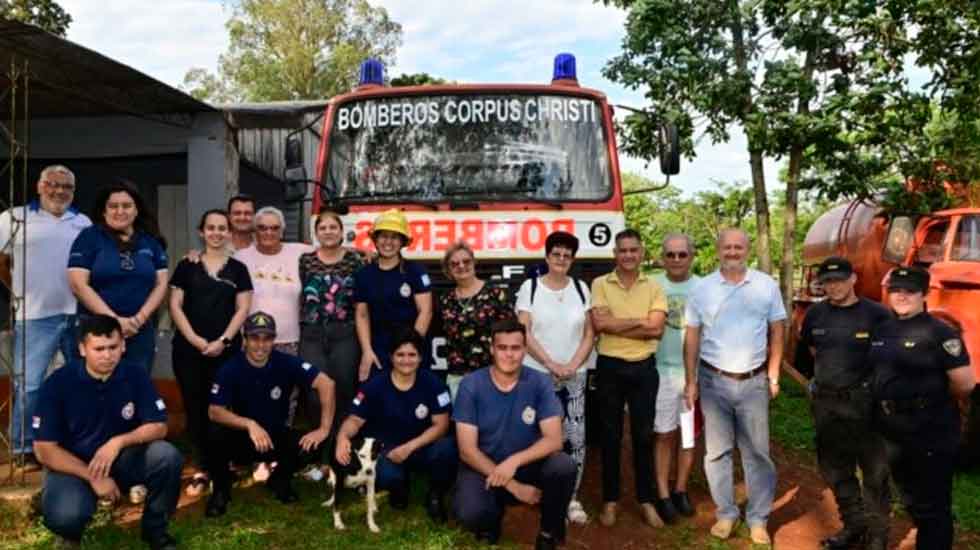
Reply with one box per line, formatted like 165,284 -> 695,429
211,350 -> 320,433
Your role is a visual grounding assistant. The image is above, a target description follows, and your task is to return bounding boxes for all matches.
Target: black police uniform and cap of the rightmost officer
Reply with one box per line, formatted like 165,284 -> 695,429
869,268 -> 970,550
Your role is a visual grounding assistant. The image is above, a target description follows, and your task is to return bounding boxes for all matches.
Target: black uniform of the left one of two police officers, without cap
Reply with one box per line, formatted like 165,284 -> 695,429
800,298 -> 891,548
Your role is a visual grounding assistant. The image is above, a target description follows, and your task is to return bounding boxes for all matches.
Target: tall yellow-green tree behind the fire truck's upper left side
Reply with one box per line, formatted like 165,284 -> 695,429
184,0 -> 401,101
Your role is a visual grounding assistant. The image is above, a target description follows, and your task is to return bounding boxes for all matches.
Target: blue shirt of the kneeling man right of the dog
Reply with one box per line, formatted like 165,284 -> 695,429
453,367 -> 562,464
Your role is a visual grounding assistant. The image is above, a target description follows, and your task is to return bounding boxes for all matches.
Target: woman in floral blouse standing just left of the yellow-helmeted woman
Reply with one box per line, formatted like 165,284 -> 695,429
299,210 -> 366,434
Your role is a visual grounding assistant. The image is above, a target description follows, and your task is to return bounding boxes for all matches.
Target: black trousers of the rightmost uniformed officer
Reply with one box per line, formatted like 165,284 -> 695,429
885,440 -> 956,550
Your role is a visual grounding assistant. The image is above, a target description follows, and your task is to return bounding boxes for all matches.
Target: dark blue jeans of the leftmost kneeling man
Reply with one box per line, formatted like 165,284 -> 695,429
41,441 -> 184,541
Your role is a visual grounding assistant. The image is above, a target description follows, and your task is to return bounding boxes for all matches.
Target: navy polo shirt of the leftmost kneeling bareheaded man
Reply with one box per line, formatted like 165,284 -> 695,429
31,362 -> 167,462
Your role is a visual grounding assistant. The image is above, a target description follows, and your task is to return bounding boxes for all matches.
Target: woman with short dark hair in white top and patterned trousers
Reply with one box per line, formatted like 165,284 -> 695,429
517,231 -> 595,523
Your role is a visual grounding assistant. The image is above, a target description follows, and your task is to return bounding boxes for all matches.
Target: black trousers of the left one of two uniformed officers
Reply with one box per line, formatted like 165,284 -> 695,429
810,386 -> 891,537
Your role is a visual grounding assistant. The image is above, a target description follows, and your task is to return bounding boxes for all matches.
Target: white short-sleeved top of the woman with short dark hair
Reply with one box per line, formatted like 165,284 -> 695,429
516,277 -> 595,373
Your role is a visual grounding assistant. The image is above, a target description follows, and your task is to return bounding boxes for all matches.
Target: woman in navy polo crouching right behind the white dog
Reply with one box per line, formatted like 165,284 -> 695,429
335,327 -> 457,522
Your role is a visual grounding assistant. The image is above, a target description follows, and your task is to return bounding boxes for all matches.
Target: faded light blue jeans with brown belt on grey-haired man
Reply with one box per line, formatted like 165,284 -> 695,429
698,368 -> 776,527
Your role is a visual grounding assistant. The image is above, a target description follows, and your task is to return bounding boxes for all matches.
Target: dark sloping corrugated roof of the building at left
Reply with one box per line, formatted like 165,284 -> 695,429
0,19 -> 216,126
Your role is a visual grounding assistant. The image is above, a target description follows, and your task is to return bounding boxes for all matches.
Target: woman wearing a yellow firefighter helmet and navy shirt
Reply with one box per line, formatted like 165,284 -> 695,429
354,209 -> 432,380
